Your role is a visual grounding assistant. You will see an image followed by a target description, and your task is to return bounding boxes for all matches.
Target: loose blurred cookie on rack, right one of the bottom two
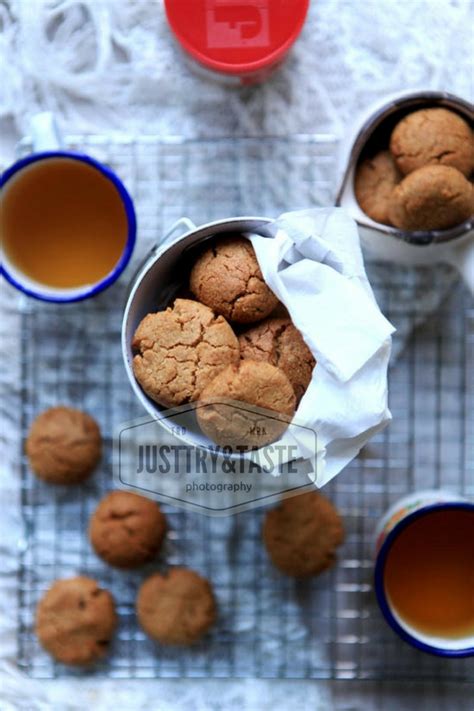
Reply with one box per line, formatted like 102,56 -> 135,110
137,568 -> 216,645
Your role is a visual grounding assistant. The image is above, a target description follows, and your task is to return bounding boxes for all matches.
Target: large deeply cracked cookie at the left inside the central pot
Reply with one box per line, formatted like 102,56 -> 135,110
132,299 -> 240,407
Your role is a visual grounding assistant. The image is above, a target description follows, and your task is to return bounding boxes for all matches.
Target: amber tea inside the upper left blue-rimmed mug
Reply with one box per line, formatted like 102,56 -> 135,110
0,158 -> 128,288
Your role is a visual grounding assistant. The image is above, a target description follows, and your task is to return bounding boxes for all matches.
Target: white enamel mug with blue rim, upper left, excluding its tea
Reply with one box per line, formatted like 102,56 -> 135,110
0,113 -> 137,303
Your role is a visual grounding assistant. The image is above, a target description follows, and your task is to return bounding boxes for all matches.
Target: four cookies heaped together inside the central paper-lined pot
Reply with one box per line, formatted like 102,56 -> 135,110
132,235 -> 316,450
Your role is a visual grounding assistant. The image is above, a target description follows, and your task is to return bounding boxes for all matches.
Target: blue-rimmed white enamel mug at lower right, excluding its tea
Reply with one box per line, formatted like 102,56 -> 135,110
374,489 -> 474,658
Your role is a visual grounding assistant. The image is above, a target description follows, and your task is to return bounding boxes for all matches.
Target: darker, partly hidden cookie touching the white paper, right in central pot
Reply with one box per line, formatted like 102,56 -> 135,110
239,318 -> 316,402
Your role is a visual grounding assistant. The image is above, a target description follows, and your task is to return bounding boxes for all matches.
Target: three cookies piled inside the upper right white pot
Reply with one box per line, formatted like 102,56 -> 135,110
354,107 -> 474,231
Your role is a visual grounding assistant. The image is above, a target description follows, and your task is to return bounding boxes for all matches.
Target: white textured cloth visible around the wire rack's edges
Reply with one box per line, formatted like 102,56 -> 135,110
0,0 -> 474,711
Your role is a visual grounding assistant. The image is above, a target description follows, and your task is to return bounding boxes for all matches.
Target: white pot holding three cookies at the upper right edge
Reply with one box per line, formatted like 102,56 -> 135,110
337,91 -> 474,289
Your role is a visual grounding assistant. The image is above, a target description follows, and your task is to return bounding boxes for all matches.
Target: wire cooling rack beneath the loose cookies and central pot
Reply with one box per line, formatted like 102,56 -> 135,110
14,136 -> 474,681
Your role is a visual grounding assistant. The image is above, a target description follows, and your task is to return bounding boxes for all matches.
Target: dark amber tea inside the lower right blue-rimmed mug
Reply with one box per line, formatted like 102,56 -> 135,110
384,509 -> 474,638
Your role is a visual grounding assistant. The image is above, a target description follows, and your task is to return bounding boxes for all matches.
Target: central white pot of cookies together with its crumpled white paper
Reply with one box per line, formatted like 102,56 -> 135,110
122,207 -> 394,486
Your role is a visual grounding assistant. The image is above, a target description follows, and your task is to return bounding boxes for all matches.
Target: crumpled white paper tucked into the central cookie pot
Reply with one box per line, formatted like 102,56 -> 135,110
247,208 -> 395,487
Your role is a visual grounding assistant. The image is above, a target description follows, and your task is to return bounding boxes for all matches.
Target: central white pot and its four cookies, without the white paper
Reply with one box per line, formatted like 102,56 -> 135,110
122,218 -> 315,452
